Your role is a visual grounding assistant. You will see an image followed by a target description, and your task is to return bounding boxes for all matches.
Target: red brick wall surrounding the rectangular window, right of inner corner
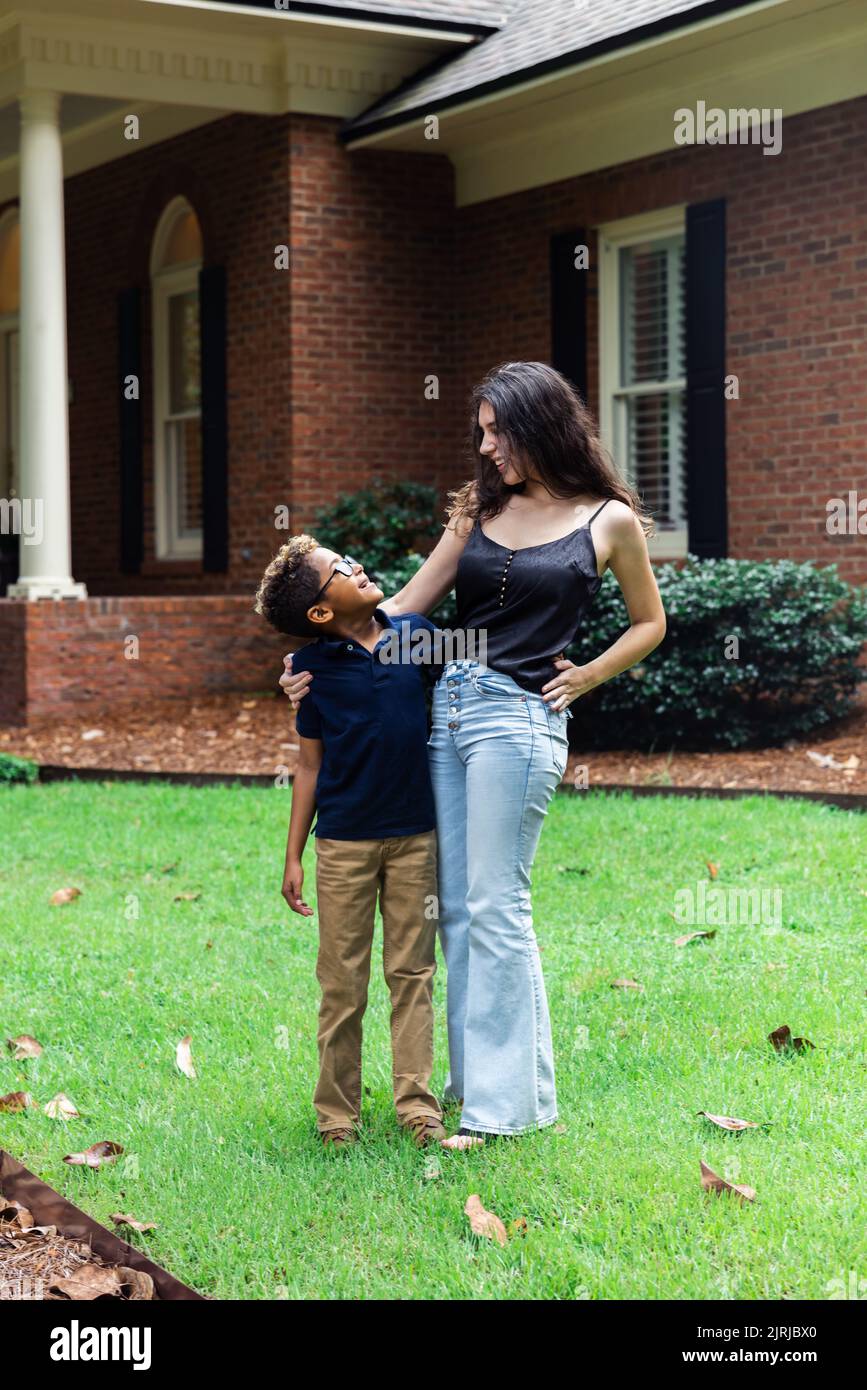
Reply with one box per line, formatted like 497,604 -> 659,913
454,97 -> 867,582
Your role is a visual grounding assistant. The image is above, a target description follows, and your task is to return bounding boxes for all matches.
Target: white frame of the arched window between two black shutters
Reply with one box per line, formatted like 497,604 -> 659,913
150,197 -> 203,560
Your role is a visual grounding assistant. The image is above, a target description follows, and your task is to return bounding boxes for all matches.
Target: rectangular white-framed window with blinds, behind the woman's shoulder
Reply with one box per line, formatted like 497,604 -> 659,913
599,207 -> 686,557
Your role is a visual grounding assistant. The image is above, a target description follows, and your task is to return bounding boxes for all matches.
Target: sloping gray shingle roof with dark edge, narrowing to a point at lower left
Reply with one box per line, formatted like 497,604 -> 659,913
342,0 -> 749,140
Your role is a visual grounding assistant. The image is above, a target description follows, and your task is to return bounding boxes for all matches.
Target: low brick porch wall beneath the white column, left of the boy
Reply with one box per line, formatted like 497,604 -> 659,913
0,595 -> 286,724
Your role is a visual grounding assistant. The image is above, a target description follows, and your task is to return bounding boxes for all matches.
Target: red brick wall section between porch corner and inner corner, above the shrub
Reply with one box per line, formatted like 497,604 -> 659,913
290,117 -> 461,520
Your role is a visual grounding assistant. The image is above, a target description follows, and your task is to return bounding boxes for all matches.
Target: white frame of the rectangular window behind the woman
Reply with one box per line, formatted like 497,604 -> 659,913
596,203 -> 688,560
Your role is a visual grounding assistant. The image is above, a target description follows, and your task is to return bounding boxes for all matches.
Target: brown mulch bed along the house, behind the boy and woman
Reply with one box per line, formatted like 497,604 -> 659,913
0,692 -> 867,795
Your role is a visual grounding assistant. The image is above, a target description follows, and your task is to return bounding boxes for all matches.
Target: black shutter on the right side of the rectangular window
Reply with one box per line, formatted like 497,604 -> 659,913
686,199 -> 728,556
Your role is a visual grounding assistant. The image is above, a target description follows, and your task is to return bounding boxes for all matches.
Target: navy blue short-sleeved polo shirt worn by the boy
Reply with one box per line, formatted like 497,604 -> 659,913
292,609 -> 436,840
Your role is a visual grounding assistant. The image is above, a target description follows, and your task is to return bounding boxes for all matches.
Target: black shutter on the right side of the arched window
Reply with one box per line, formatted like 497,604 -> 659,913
199,265 -> 229,571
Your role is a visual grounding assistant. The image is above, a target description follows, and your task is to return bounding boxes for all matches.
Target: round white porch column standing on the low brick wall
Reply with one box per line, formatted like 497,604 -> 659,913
8,90 -> 88,599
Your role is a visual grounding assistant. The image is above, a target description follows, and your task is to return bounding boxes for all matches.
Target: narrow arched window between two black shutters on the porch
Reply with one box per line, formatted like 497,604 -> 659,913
150,197 -> 201,560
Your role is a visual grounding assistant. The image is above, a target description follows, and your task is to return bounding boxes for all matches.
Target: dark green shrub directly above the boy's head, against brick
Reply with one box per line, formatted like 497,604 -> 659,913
314,480 -> 442,578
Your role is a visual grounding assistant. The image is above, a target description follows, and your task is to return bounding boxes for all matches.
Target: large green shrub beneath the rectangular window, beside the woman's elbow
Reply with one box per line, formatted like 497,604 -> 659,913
567,556 -> 867,749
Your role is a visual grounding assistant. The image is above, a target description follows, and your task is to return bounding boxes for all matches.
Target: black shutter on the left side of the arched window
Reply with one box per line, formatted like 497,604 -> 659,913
118,286 -> 145,574
